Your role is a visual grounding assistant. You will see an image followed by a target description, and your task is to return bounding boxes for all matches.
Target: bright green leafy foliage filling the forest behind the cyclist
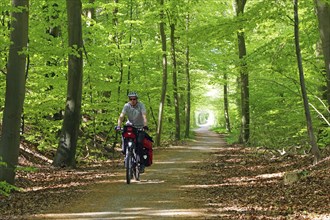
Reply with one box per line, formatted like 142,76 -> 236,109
0,0 -> 330,164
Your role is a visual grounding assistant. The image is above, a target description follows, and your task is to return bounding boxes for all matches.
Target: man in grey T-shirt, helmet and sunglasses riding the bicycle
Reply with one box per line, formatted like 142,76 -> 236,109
116,92 -> 148,173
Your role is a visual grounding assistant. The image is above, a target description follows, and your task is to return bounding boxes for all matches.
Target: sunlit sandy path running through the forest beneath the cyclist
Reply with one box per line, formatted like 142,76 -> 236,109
33,128 -> 225,219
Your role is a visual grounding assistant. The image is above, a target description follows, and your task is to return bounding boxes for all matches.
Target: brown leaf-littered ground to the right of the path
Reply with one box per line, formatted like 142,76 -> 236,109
187,145 -> 330,219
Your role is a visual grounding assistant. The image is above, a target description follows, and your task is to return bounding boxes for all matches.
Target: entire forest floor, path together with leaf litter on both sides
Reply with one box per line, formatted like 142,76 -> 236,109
0,128 -> 330,219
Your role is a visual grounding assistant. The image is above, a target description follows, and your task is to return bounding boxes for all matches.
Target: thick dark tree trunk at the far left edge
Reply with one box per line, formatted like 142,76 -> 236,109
0,0 -> 29,184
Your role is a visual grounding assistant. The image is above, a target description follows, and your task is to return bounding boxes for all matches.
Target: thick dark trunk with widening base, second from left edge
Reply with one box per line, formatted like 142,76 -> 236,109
53,0 -> 83,167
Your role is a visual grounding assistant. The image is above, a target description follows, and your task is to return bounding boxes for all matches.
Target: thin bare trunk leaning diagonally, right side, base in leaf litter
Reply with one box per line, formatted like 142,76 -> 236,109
293,0 -> 321,164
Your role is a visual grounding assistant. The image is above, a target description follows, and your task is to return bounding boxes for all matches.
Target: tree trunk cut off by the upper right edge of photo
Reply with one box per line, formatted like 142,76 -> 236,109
315,0 -> 330,109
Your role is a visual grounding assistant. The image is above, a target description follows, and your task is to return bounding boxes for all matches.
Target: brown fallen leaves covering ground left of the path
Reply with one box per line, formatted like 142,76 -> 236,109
0,161 -> 119,220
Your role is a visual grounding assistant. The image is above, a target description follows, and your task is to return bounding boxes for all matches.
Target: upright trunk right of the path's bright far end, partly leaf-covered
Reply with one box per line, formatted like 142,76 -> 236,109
234,0 -> 250,144
